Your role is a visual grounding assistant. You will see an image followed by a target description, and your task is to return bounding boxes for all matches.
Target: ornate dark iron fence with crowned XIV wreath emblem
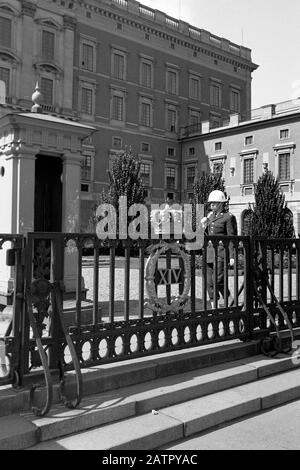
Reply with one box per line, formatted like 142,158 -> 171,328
0,233 -> 300,392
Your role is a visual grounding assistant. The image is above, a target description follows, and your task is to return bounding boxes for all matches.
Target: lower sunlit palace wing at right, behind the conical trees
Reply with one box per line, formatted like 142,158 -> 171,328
180,98 -> 300,236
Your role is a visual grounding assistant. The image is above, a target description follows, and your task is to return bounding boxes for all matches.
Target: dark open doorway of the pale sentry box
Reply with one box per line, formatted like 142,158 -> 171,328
34,155 -> 63,232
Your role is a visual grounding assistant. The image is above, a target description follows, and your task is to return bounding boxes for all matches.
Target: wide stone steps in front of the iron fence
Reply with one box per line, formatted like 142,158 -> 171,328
0,332 -> 300,450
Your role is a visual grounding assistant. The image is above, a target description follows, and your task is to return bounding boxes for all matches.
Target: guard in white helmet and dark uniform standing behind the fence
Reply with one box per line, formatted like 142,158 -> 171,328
201,190 -> 237,308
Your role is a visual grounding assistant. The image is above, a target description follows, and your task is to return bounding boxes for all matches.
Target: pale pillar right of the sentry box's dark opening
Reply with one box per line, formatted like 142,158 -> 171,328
62,153 -> 84,297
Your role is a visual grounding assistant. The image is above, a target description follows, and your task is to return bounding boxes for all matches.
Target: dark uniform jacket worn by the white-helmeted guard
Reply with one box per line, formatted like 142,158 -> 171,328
206,212 -> 237,263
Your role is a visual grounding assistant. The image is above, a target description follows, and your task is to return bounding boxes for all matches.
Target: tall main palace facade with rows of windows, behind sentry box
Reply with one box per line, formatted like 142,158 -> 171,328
0,0 -> 257,228
